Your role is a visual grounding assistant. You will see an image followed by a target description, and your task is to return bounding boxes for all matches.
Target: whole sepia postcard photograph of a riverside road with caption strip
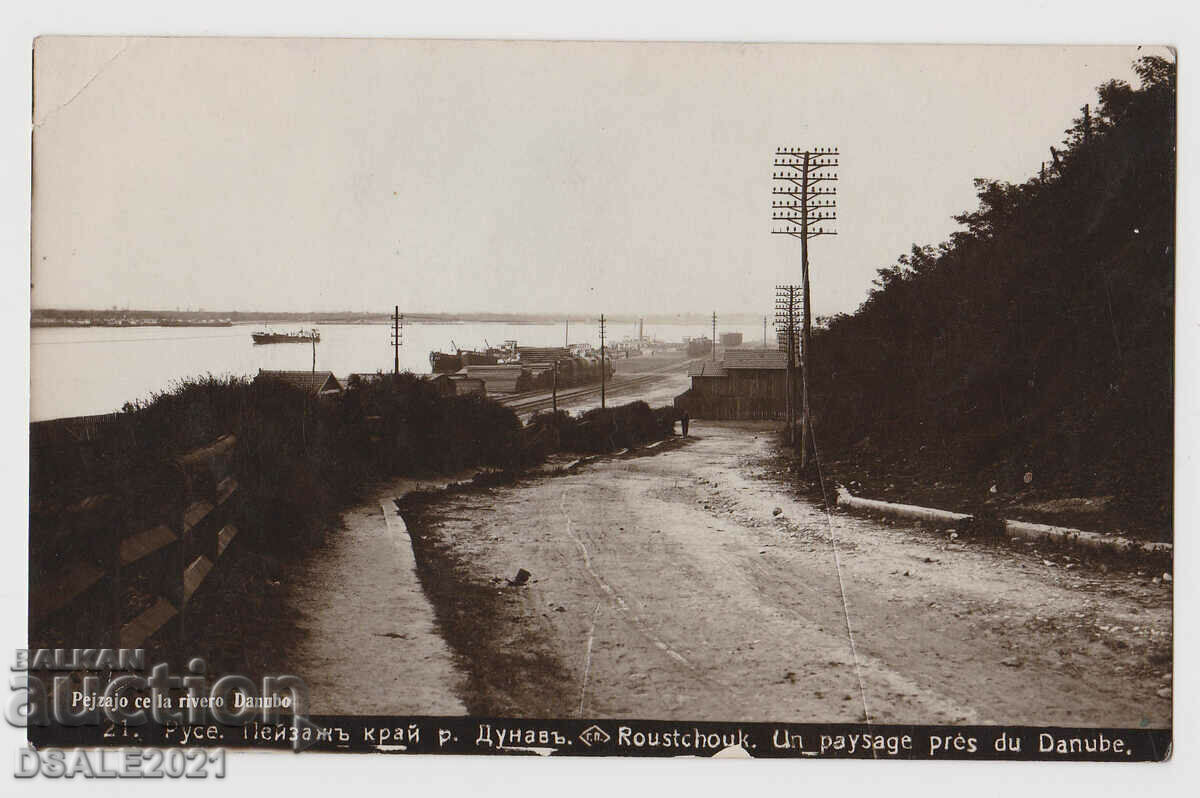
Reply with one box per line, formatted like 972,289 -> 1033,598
17,36 -> 1177,768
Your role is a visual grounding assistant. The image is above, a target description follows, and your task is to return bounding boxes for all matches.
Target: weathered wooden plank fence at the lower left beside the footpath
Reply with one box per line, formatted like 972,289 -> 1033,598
30,434 -> 239,648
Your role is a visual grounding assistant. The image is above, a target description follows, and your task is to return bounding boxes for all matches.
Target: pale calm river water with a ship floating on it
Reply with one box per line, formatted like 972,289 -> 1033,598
30,322 -> 762,421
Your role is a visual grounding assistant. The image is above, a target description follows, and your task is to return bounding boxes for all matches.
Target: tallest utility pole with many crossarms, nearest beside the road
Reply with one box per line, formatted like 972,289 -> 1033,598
770,148 -> 838,468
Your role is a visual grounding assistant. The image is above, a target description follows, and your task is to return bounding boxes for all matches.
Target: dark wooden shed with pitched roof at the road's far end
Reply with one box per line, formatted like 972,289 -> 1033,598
674,349 -> 787,419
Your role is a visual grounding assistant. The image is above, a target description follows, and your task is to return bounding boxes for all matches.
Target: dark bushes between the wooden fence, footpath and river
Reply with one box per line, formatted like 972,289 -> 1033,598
31,374 -> 673,557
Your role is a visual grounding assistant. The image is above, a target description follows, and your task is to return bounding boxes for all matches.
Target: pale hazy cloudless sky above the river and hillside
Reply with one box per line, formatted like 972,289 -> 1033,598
25,38 -> 1159,314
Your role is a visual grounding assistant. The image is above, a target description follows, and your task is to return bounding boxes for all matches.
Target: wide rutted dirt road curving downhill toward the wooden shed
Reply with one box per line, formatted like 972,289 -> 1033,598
404,422 -> 1172,727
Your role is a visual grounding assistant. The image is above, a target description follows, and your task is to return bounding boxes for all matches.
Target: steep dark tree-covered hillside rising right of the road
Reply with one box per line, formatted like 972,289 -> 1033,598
811,58 -> 1176,530
